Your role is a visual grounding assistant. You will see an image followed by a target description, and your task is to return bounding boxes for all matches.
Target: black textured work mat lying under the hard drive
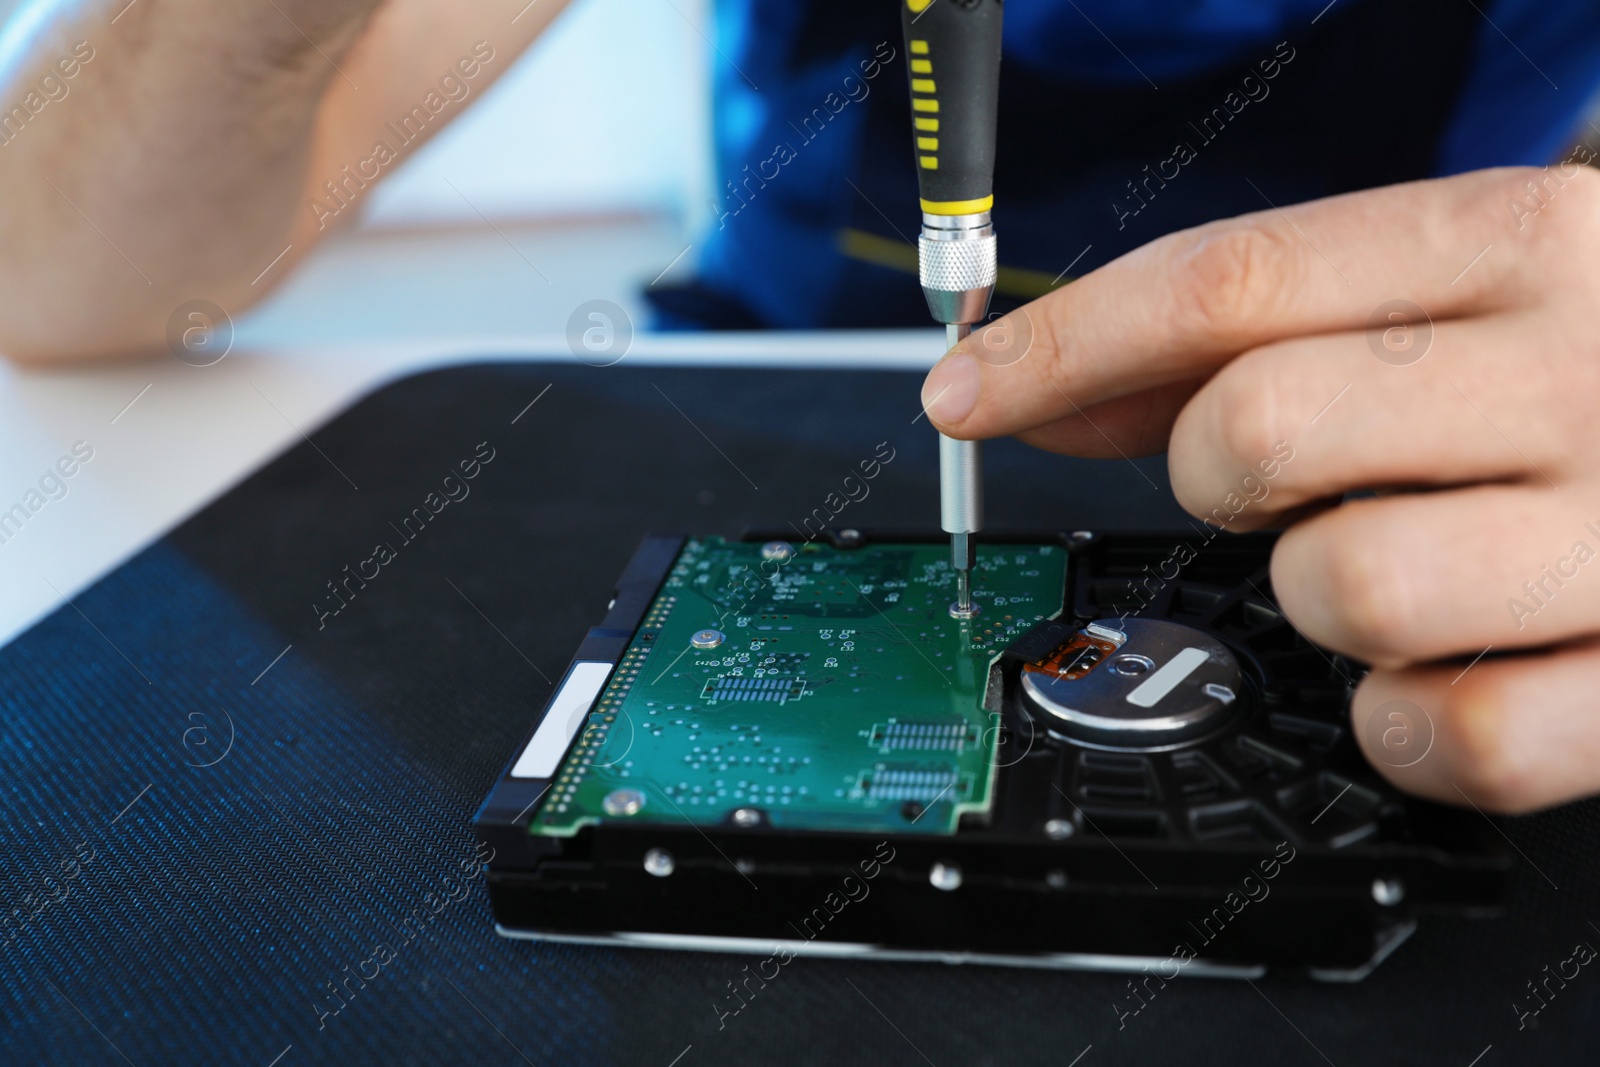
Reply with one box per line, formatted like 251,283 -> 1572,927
0,363 -> 1600,1067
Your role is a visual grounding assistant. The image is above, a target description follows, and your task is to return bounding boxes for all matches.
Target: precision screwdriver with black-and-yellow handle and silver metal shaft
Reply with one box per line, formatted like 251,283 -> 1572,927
901,0 -> 1003,619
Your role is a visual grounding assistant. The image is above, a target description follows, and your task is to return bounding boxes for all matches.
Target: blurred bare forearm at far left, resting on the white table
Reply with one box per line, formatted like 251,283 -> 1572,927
0,0 -> 378,358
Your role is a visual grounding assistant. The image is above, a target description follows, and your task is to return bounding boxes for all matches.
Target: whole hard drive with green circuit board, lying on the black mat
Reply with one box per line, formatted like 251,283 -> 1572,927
475,530 -> 1509,979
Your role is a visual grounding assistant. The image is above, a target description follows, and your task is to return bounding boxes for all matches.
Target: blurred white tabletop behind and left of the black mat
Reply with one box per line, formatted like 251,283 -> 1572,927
0,219 -> 942,645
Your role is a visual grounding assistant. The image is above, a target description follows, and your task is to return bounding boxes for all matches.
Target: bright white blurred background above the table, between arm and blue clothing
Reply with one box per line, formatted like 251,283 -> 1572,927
366,0 -> 714,229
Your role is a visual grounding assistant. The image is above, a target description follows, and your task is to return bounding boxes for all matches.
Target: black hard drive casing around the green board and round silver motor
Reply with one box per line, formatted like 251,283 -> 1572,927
474,531 -> 1509,981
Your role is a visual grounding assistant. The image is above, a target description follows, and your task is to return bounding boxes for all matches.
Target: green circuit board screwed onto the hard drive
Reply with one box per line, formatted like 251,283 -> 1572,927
530,537 -> 1067,837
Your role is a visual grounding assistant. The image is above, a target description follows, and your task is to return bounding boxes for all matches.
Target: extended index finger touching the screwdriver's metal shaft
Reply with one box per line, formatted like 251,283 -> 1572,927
922,165 -> 1568,438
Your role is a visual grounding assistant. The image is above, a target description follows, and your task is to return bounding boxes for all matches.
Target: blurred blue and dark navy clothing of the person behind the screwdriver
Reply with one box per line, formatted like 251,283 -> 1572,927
658,0 -> 1600,328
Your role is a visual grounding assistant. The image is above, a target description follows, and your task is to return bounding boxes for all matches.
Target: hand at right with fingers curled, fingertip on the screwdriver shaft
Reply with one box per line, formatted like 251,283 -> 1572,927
923,163 -> 1600,811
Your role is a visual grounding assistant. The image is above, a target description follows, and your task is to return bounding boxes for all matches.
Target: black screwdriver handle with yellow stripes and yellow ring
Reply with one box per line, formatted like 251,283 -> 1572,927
901,0 -> 1003,214
